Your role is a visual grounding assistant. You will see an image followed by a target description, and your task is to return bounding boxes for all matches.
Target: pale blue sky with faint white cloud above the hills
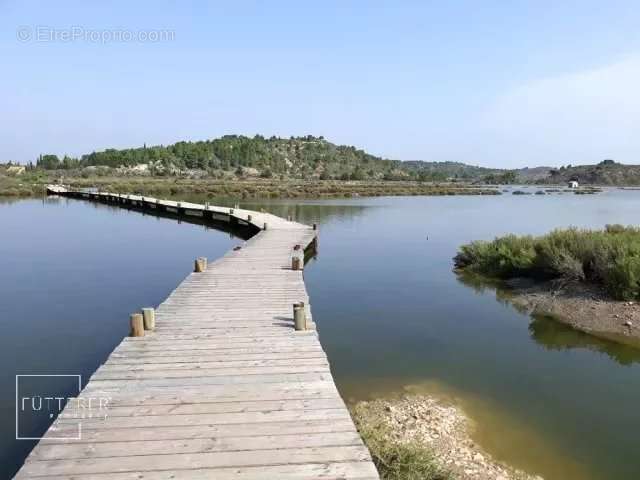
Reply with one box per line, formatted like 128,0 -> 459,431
0,0 -> 640,167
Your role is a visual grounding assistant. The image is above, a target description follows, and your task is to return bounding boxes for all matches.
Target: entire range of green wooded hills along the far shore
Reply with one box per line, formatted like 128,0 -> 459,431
8,135 -> 640,186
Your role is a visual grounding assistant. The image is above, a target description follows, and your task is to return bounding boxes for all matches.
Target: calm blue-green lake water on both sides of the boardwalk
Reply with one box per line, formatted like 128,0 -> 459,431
0,190 -> 640,480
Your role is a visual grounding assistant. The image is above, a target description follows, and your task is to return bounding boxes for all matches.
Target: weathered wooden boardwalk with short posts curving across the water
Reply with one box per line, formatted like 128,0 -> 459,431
16,191 -> 378,480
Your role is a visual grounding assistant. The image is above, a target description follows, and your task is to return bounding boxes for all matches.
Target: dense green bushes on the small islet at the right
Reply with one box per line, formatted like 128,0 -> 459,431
454,225 -> 640,300
